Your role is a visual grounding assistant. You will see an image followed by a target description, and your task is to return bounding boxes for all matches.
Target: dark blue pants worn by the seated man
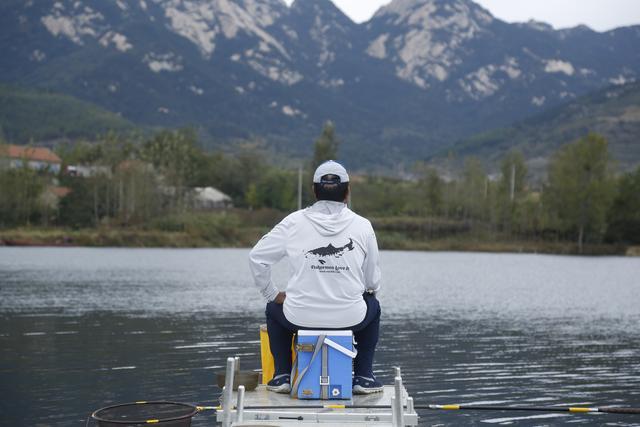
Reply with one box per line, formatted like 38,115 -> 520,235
266,294 -> 380,378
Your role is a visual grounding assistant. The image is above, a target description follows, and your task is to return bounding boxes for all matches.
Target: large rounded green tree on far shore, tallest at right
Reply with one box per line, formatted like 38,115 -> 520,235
544,134 -> 615,253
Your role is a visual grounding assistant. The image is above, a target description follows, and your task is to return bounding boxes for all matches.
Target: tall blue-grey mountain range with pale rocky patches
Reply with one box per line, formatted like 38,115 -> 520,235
0,0 -> 640,171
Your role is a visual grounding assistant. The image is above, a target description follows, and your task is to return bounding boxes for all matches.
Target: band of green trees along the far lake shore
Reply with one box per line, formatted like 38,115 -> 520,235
0,122 -> 640,251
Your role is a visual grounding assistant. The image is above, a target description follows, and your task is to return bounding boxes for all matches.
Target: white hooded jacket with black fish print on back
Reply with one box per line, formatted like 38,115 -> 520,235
249,200 -> 380,328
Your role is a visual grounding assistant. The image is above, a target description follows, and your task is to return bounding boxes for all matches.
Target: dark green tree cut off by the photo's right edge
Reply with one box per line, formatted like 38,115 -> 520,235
607,167 -> 640,244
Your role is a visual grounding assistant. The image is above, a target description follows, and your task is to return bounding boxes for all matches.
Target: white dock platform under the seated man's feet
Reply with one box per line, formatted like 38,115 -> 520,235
217,363 -> 418,427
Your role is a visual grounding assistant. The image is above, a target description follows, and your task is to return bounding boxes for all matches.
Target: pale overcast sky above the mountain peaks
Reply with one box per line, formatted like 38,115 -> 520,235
285,0 -> 640,31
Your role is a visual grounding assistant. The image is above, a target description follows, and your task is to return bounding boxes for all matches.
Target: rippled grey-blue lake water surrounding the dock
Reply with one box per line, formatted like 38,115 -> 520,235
0,248 -> 640,427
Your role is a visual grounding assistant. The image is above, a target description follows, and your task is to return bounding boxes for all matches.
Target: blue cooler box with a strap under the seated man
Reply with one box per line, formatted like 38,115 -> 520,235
292,330 -> 356,399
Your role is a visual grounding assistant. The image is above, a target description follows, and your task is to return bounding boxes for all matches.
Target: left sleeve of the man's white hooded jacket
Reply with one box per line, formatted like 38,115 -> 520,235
249,217 -> 288,301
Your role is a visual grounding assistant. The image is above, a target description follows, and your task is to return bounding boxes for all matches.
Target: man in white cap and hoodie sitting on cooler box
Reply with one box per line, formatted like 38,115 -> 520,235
249,160 -> 382,394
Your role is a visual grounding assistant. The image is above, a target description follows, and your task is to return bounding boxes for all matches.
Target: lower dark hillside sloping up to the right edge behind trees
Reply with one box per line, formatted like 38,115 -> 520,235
438,82 -> 640,178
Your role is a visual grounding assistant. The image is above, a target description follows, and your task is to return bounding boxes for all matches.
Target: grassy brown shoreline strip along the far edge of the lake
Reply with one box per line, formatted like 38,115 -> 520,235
0,227 -> 640,257
